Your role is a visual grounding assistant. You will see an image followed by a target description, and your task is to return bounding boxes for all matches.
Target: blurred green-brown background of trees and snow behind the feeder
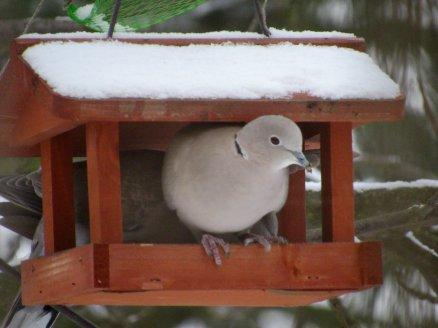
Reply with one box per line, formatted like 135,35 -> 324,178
0,0 -> 438,327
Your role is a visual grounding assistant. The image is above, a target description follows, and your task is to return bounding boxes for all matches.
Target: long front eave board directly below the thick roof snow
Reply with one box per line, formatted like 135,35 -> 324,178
54,95 -> 404,123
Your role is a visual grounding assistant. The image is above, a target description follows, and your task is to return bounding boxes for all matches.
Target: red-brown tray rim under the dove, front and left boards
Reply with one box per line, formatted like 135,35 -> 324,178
22,242 -> 382,306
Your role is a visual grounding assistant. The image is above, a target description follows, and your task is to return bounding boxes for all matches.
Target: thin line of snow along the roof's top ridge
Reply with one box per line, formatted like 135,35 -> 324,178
19,28 -> 355,39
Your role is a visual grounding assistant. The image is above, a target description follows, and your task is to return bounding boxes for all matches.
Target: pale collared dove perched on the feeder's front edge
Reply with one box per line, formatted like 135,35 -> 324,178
162,115 -> 310,265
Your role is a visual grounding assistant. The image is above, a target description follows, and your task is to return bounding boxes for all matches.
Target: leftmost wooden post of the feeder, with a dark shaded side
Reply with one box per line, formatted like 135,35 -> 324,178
41,133 -> 76,255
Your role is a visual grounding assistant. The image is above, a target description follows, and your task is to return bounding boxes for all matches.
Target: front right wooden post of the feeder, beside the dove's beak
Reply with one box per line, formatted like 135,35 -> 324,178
321,122 -> 354,242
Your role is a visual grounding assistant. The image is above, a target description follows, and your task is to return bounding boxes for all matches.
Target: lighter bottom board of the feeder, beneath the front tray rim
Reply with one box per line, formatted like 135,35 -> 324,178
62,289 -> 350,307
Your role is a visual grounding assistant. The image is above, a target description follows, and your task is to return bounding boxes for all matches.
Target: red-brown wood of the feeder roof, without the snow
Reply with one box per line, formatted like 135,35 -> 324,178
0,38 -> 404,151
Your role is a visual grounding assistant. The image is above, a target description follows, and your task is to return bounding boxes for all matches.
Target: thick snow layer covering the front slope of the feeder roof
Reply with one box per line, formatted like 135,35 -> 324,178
23,40 -> 400,100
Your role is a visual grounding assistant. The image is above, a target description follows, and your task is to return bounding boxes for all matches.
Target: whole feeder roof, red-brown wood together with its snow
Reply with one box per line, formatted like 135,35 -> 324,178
0,30 -> 404,155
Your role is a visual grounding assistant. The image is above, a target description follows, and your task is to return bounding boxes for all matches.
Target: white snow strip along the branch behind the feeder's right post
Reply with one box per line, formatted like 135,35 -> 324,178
306,179 -> 438,192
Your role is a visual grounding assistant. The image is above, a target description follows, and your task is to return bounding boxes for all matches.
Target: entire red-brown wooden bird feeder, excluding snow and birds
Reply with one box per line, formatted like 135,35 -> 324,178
0,33 -> 404,306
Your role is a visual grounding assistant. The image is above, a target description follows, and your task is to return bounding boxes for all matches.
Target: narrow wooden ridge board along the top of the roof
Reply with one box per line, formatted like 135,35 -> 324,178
11,38 -> 366,54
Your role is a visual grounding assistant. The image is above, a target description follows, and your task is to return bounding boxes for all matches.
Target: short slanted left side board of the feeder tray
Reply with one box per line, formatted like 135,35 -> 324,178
21,245 -> 107,304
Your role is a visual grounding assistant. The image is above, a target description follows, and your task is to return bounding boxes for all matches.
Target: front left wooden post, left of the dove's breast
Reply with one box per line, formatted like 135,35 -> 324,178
86,122 -> 123,244
